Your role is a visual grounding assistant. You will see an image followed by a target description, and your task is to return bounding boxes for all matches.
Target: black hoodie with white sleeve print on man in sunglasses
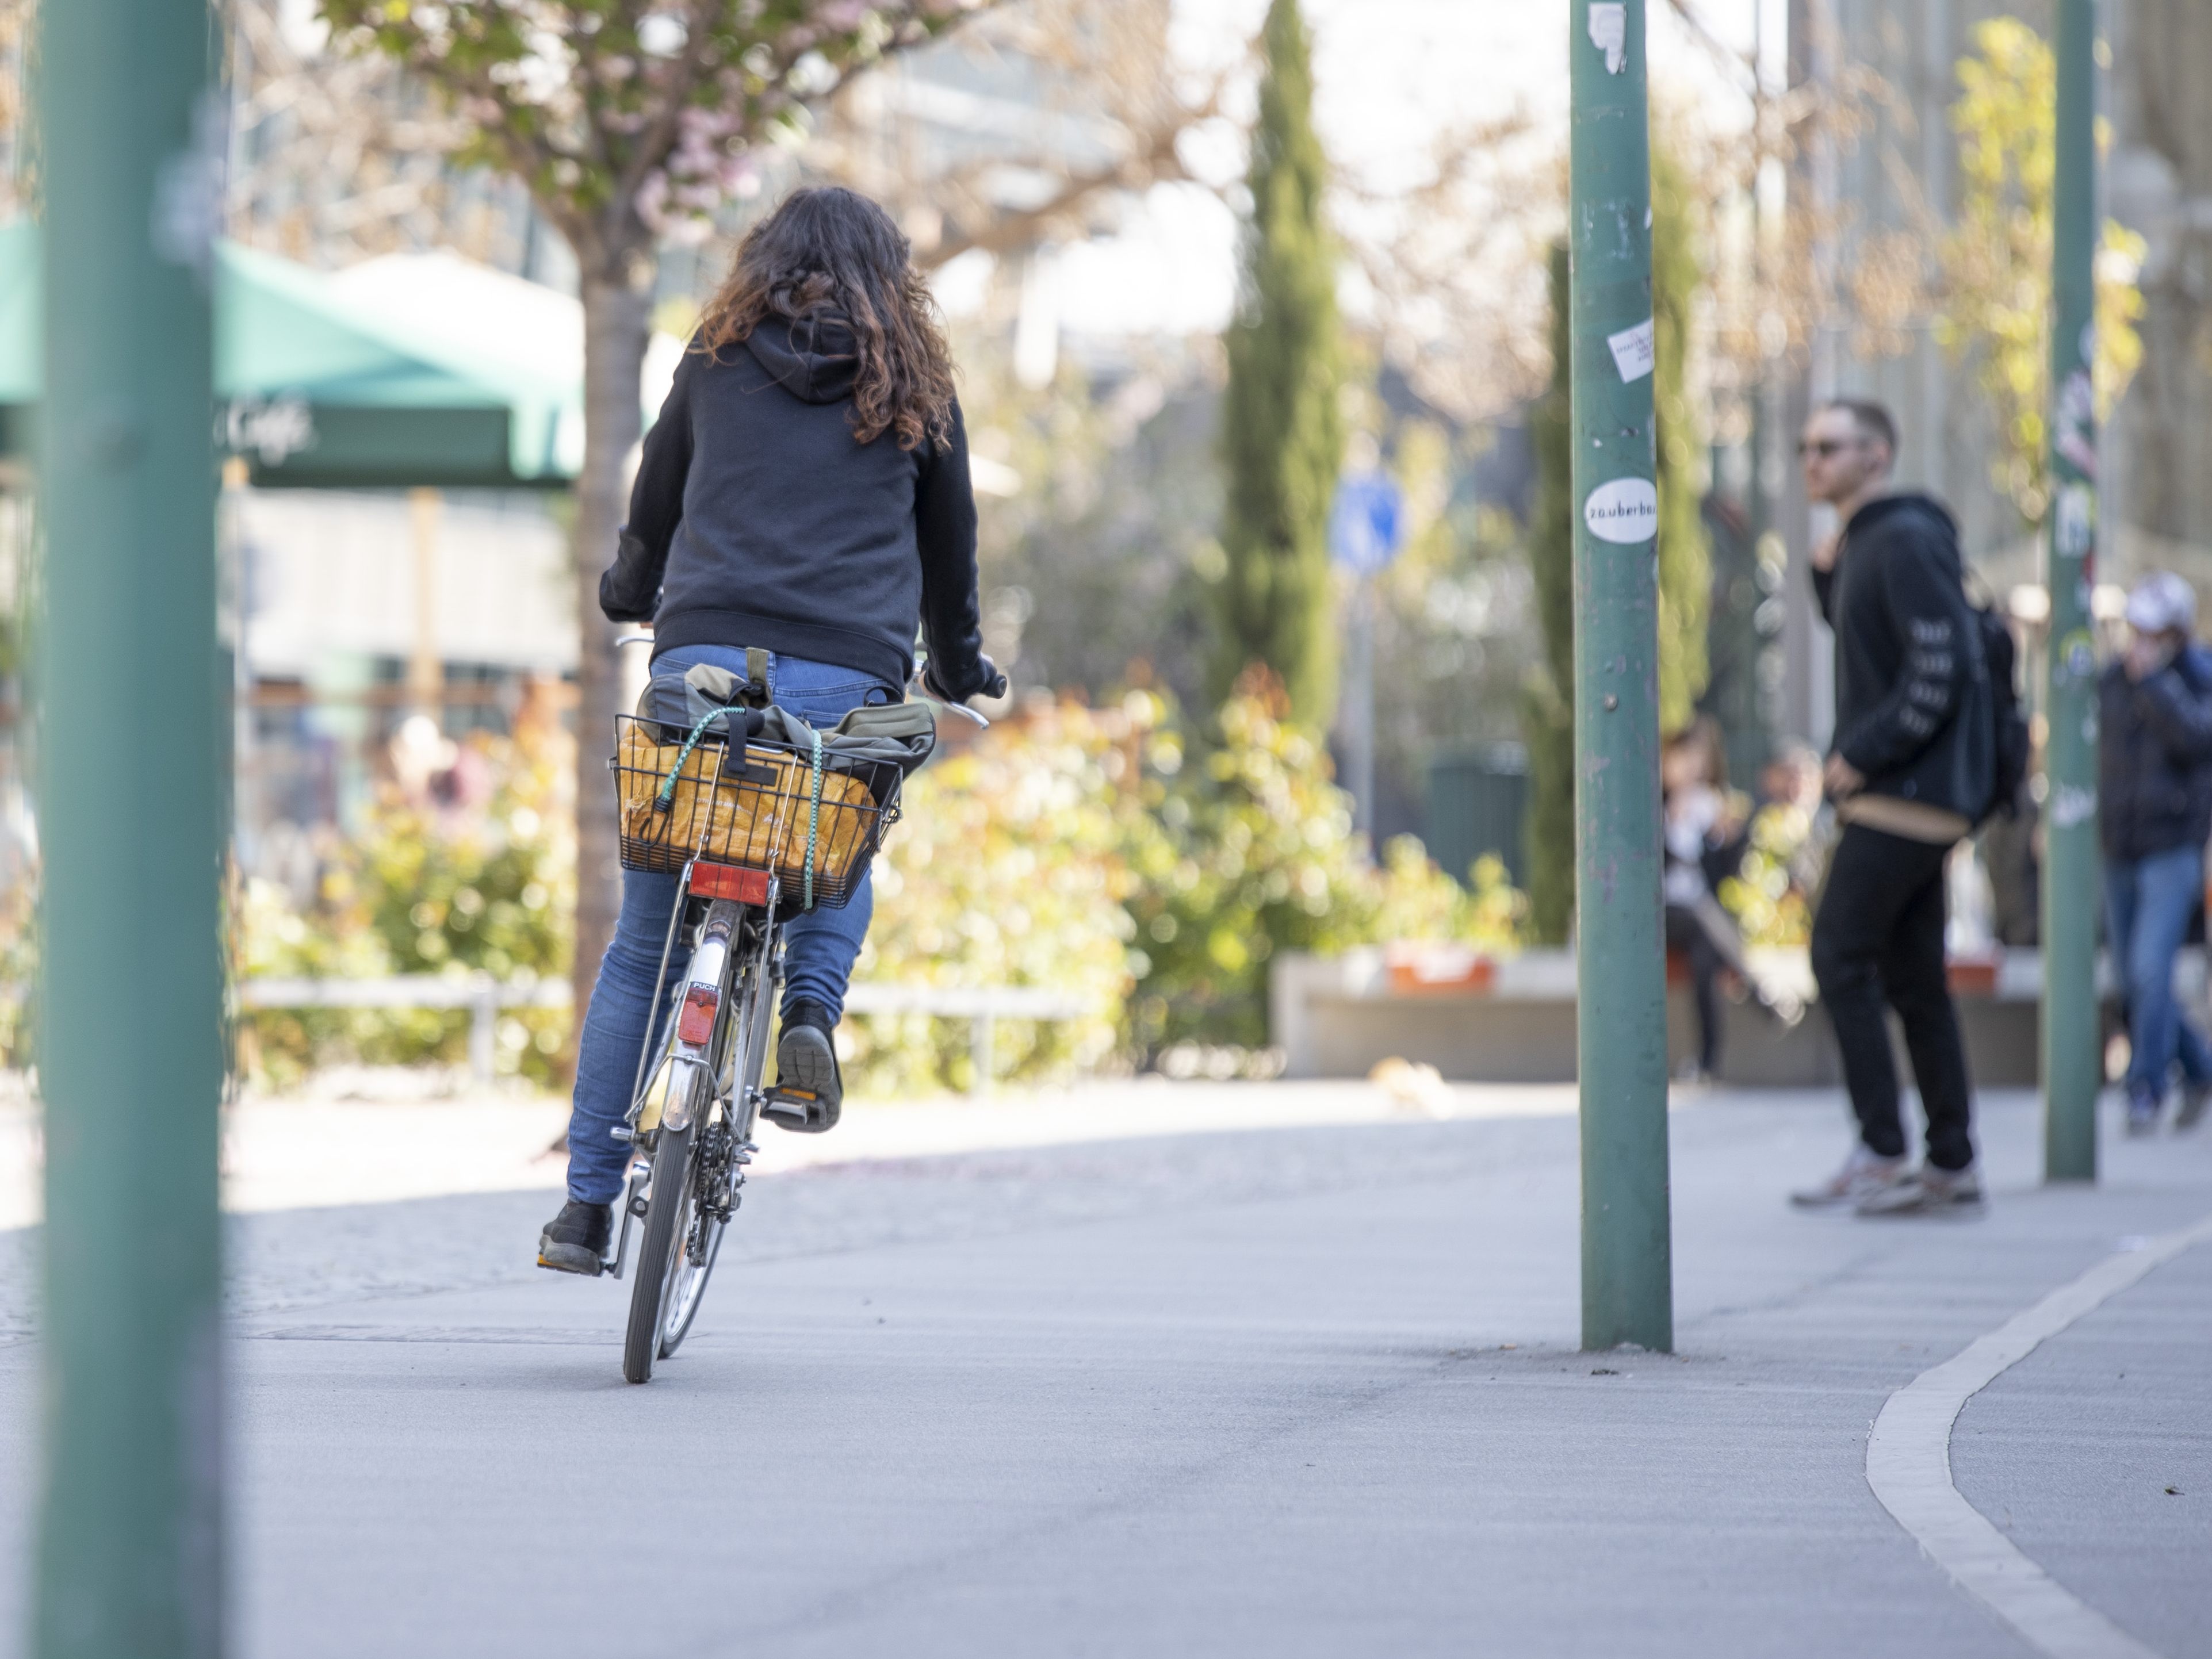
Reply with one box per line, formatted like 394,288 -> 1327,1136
1814,493 -> 1997,823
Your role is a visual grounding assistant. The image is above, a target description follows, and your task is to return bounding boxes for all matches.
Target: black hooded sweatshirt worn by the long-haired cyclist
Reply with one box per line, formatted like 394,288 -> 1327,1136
599,310 -> 991,699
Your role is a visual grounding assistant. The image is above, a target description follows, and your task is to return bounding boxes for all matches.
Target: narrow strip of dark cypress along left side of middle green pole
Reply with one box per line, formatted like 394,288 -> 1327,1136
1522,241 -> 1575,945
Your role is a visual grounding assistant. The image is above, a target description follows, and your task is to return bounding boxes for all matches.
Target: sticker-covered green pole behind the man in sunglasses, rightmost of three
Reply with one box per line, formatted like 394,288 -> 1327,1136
2042,0 -> 2104,1181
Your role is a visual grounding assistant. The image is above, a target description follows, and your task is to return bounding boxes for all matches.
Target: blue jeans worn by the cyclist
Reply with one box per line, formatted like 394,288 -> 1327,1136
568,646 -> 900,1204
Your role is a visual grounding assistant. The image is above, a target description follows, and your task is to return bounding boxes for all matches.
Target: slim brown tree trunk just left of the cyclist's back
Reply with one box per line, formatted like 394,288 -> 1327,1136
568,270 -> 653,1058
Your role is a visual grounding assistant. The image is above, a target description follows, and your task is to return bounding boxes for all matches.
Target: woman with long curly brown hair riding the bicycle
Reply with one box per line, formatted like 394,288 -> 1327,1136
538,188 -> 1007,1274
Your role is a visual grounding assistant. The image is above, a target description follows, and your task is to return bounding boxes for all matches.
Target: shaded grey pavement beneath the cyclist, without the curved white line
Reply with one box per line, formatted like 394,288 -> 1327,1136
0,1095 -> 2212,1659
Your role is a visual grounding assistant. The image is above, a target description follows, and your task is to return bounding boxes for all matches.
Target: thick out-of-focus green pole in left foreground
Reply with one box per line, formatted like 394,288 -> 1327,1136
31,0 -> 228,1659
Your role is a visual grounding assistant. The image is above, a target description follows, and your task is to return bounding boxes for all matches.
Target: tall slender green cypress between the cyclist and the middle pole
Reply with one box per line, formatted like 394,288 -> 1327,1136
1212,0 -> 1345,728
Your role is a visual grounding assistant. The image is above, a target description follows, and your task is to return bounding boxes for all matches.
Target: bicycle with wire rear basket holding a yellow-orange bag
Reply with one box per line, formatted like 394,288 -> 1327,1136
599,641 -> 989,1382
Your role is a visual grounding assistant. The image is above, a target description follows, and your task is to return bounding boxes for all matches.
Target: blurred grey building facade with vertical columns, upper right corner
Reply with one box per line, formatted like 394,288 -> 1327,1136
1772,0 -> 2212,741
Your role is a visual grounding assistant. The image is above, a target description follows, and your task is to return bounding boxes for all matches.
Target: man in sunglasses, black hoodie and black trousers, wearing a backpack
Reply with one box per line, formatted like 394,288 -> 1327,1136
1794,400 -> 1995,1214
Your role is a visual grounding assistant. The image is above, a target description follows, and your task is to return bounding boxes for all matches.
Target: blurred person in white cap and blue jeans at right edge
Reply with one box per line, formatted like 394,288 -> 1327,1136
2097,570 -> 2212,1135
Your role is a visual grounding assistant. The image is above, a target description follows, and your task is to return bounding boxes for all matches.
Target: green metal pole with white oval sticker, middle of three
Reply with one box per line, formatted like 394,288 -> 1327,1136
1568,0 -> 1674,1351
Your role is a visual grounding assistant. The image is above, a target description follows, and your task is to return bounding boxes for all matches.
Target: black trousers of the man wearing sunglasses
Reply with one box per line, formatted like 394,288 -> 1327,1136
1812,823 -> 1973,1170
